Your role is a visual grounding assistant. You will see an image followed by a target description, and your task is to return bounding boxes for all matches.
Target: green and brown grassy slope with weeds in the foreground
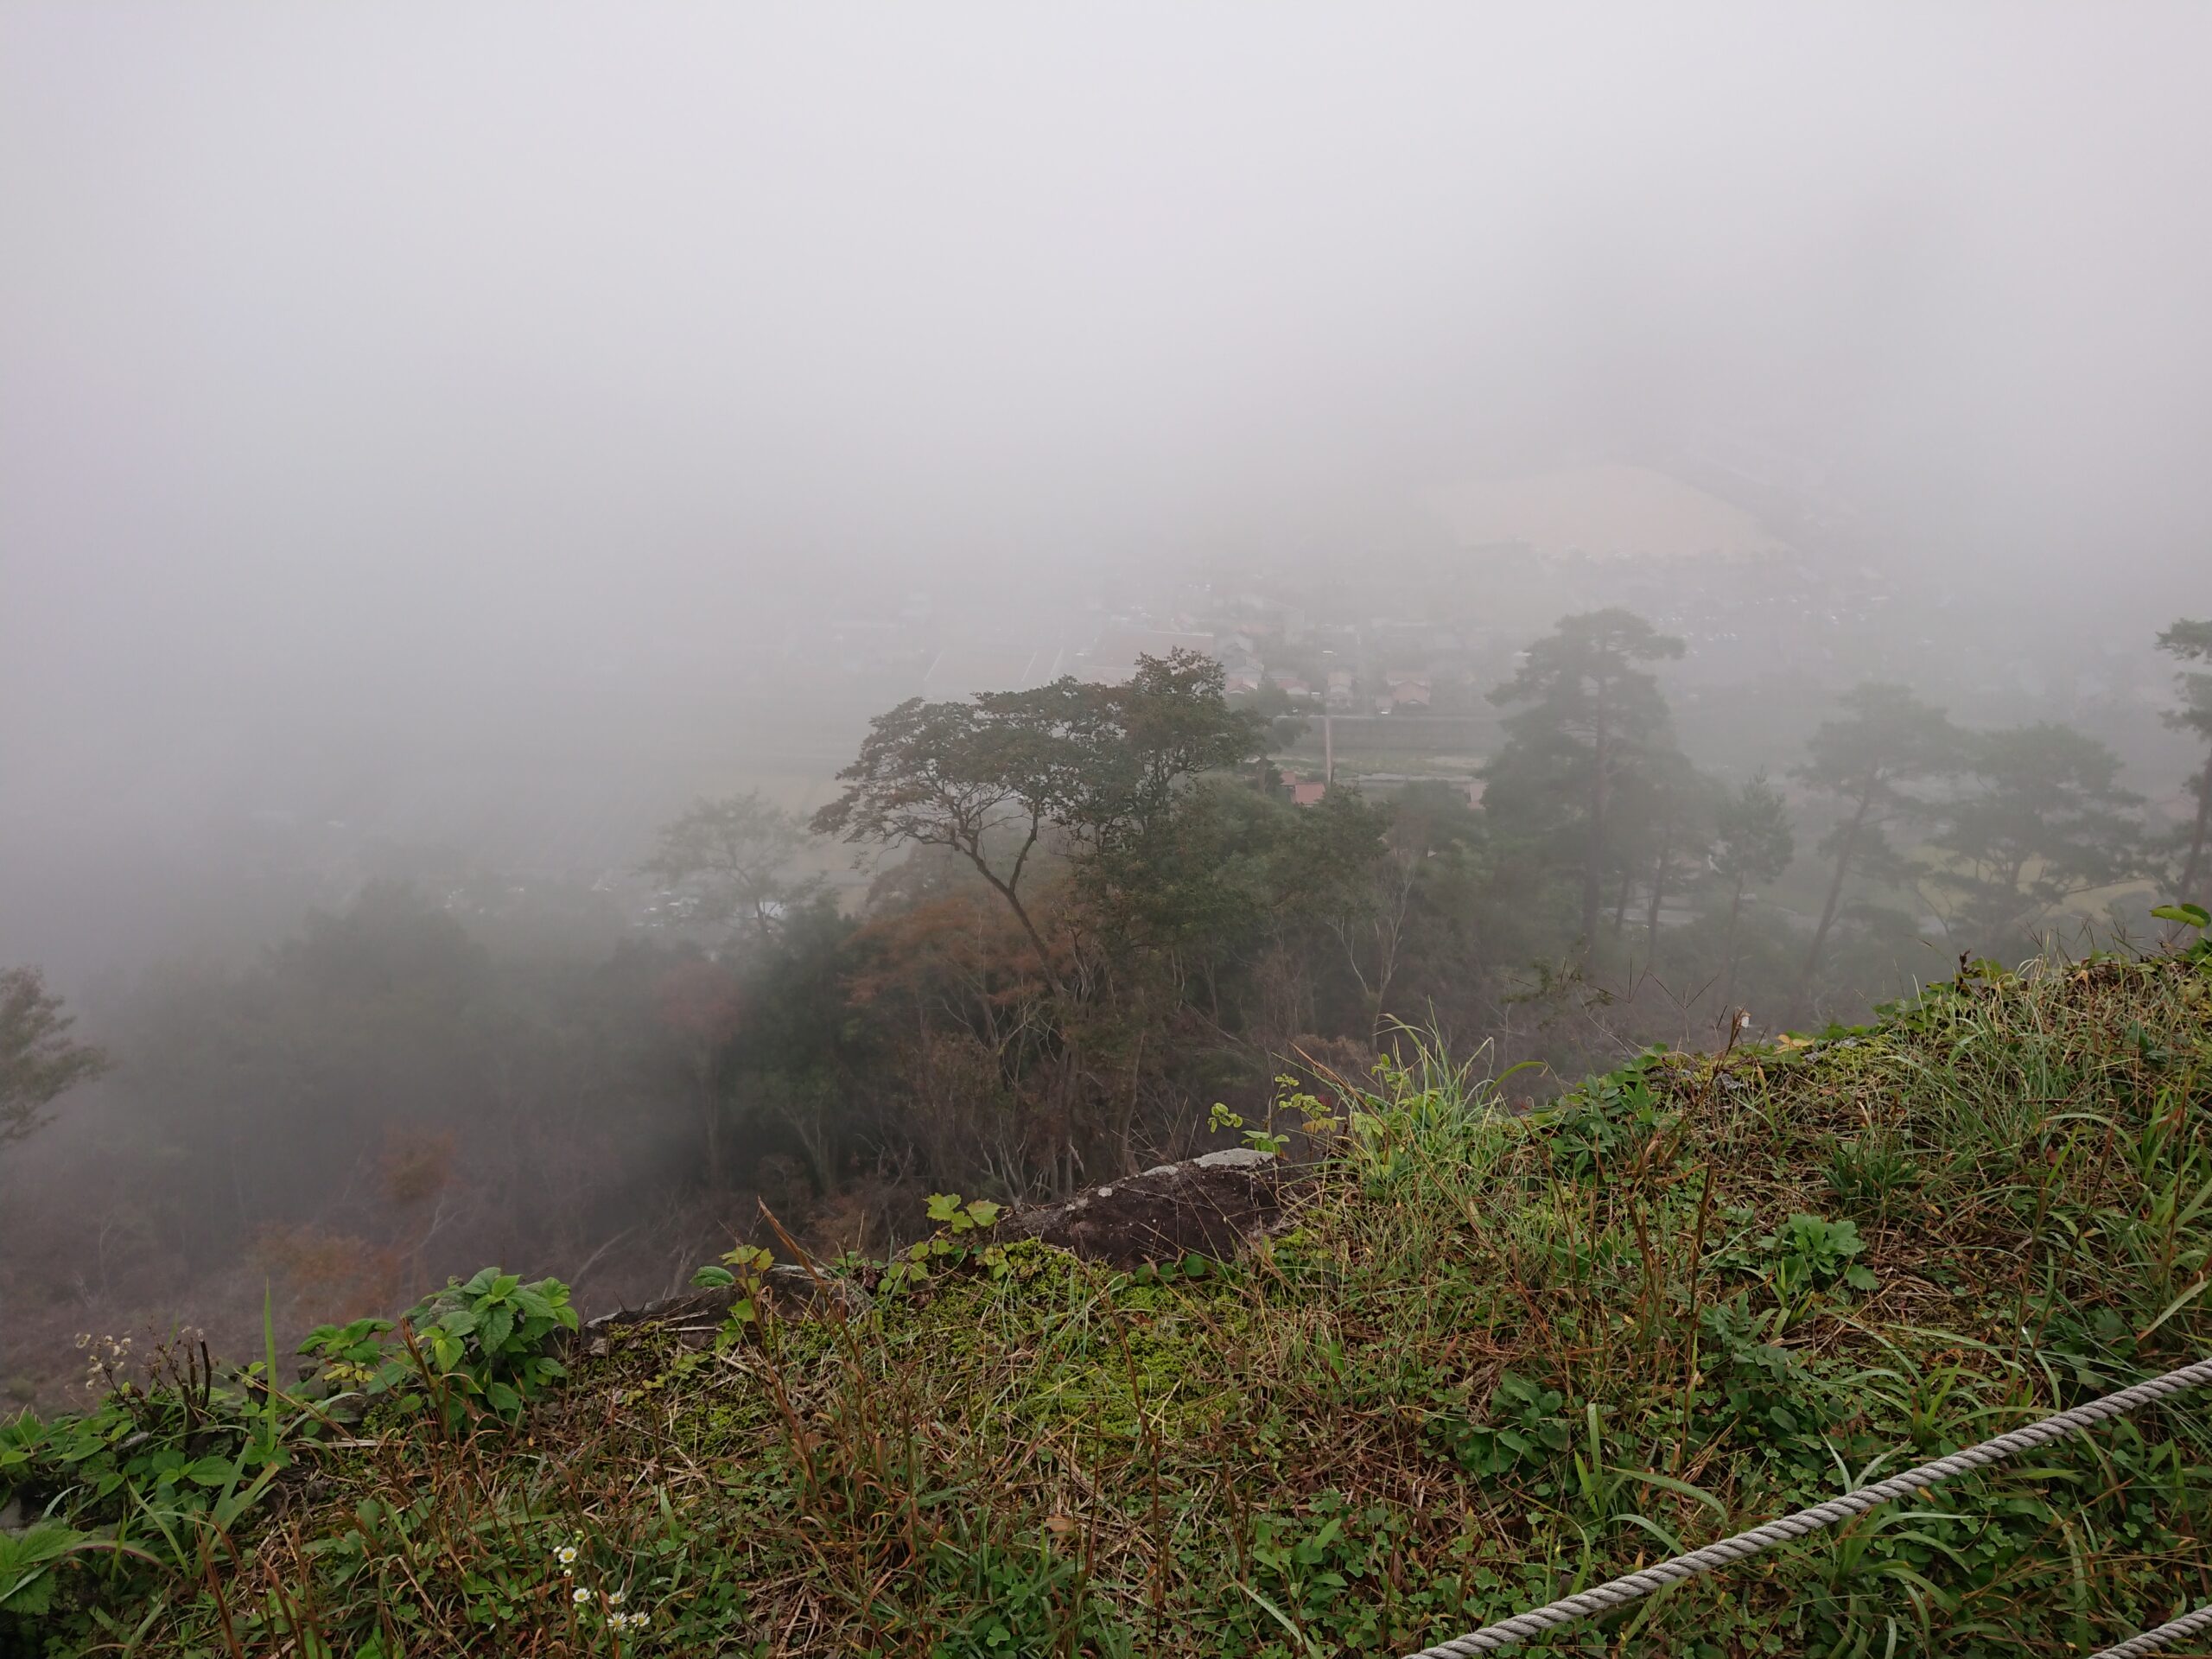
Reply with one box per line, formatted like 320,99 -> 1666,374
13,956 -> 2212,1656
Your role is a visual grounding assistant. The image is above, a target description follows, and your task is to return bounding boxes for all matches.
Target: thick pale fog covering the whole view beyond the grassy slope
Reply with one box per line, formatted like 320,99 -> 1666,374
13,0 -> 2212,1414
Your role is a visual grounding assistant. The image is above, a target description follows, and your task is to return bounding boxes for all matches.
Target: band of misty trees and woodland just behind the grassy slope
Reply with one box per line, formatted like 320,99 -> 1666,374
0,611 -> 2212,1405
